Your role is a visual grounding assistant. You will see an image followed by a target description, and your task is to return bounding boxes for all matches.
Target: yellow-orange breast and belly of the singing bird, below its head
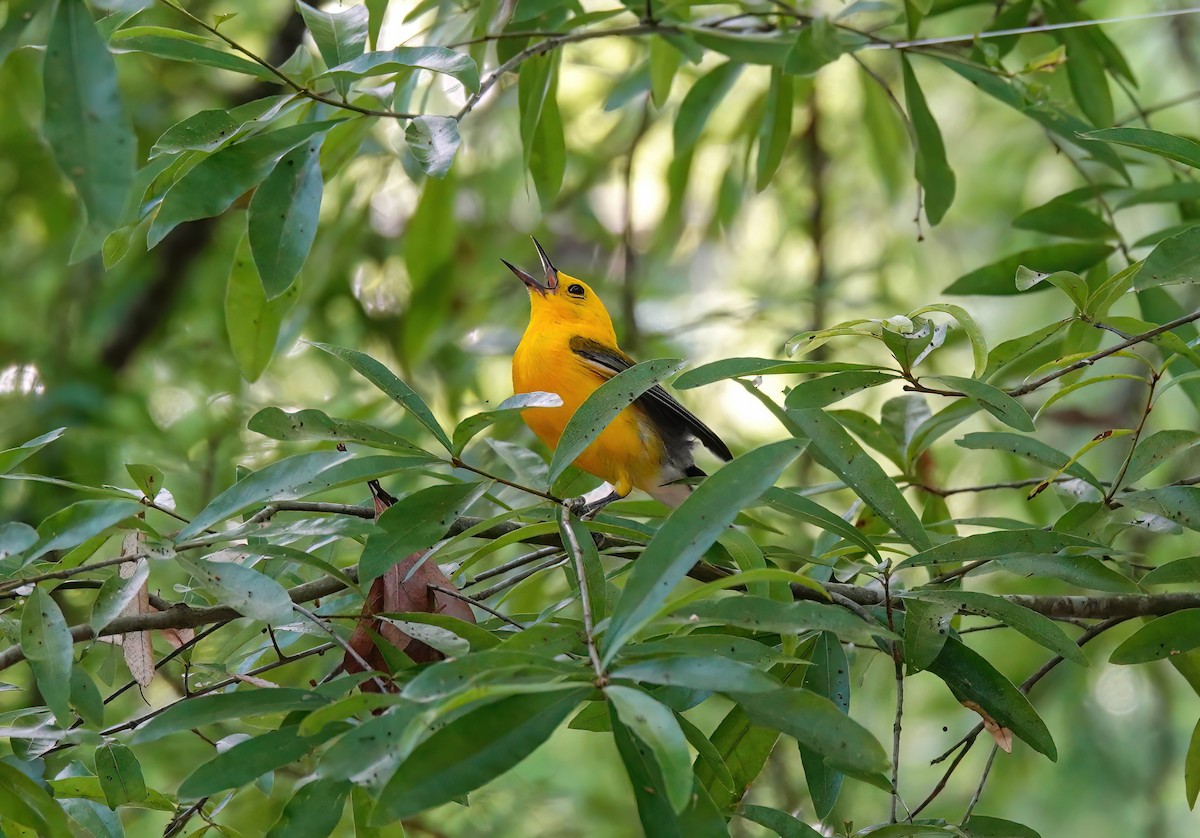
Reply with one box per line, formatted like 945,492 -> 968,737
512,328 -> 662,496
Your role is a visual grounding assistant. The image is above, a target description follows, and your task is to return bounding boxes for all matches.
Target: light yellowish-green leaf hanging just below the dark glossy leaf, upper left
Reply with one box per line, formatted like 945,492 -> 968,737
224,234 -> 298,382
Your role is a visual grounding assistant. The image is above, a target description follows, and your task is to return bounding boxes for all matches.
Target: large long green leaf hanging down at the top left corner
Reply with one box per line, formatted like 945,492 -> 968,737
43,0 -> 137,235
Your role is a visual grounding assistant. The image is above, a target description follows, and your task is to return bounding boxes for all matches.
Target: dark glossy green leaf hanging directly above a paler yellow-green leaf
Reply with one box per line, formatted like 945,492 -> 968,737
247,135 -> 324,300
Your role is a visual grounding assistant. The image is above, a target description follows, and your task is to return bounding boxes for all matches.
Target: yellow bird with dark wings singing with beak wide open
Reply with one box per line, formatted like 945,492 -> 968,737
502,239 -> 733,515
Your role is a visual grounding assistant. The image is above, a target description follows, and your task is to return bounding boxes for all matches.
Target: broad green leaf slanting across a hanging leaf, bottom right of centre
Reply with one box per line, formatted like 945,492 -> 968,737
731,688 -> 888,774
